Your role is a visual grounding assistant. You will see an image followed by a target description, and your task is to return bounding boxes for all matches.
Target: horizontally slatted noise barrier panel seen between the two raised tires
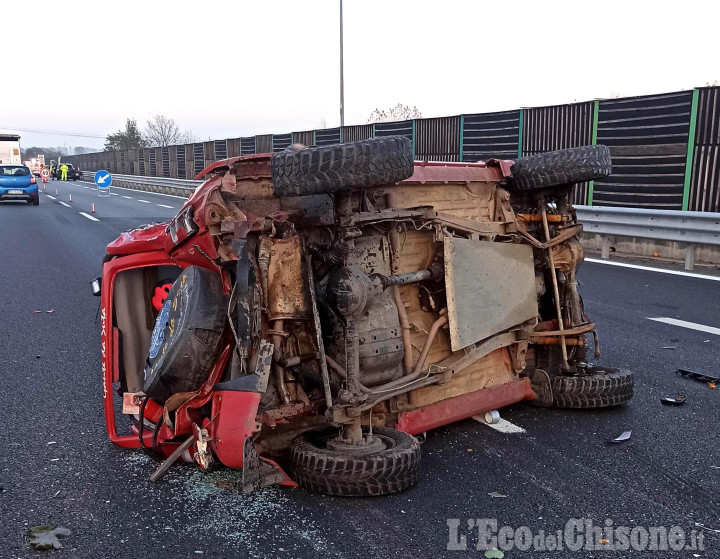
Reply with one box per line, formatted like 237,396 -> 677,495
462,110 -> 520,162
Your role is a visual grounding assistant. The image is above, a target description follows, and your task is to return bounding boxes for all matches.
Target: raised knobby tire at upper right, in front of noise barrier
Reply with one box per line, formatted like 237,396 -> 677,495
509,145 -> 612,192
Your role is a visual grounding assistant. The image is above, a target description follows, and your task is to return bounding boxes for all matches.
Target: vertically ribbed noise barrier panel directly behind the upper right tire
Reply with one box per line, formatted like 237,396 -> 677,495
522,101 -> 594,204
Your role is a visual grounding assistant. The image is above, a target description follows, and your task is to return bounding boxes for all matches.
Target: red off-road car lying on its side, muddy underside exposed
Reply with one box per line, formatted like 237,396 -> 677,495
98,137 -> 633,496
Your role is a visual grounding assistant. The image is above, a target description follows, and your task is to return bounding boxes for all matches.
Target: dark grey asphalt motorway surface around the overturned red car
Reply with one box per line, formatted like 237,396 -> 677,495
0,181 -> 720,559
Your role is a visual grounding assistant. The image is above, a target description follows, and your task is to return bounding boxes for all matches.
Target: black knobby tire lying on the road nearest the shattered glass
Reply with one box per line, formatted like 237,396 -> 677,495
290,427 -> 420,497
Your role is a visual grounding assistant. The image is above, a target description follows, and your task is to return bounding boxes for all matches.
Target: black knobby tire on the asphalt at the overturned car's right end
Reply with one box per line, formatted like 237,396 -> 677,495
552,367 -> 633,408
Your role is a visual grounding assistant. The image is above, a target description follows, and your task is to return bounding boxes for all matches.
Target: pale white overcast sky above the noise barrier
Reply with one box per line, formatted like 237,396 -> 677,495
0,0 -> 720,148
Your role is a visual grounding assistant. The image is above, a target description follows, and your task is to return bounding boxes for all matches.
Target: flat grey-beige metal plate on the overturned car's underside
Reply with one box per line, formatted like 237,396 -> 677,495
444,237 -> 538,351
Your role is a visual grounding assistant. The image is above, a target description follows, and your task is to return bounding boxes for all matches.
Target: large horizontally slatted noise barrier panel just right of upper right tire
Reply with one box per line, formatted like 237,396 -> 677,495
593,91 -> 693,210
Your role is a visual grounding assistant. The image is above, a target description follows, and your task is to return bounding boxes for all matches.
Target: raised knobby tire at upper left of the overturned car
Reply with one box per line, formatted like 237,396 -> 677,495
270,136 -> 413,196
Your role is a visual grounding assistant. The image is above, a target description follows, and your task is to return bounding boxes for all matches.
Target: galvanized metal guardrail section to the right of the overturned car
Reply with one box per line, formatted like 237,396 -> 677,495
575,206 -> 720,270
